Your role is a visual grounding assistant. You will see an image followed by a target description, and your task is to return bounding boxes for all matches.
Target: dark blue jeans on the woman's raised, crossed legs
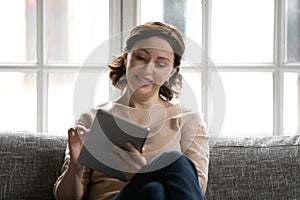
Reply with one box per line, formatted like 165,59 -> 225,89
112,151 -> 203,200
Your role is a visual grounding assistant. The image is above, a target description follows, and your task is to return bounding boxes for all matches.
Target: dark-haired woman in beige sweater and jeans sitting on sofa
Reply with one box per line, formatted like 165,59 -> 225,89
54,22 -> 209,200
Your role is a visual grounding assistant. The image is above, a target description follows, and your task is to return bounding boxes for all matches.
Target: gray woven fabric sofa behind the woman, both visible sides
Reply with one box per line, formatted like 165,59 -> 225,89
0,132 -> 300,200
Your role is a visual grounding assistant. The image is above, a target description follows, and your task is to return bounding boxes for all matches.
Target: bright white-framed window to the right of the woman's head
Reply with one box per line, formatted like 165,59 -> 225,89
139,0 -> 300,136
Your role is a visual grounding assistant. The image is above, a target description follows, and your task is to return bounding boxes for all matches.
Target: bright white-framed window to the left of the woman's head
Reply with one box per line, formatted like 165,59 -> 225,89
0,0 -> 109,133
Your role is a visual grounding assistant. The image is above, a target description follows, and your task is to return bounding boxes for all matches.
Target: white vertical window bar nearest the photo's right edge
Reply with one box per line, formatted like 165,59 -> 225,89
273,0 -> 286,135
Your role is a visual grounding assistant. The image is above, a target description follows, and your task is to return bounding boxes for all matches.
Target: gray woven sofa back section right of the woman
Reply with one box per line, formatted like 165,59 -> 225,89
205,135 -> 300,200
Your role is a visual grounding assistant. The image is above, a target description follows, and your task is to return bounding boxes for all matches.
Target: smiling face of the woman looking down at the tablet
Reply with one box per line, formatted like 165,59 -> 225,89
125,37 -> 175,97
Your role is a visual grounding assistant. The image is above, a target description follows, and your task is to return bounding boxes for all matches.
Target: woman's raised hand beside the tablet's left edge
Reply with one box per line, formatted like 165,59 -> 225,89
68,128 -> 85,168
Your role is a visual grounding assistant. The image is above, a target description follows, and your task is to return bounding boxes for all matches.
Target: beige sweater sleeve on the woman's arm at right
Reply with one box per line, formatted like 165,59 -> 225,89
181,113 -> 209,194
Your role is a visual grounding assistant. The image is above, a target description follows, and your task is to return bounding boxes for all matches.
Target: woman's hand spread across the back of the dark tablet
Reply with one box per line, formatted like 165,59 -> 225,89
113,142 -> 147,180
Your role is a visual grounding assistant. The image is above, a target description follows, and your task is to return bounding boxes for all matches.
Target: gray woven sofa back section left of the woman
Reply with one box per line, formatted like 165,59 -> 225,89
0,132 -> 67,200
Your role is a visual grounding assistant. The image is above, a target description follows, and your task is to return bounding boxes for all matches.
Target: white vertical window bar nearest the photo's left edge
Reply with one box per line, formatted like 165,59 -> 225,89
36,0 -> 48,132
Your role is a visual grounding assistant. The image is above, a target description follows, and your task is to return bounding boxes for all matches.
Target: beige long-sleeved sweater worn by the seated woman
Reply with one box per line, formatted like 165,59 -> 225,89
54,103 -> 209,200
